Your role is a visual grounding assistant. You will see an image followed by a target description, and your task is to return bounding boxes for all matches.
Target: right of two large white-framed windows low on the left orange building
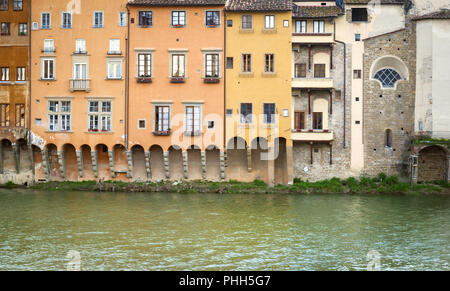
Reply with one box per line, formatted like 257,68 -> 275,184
88,101 -> 112,132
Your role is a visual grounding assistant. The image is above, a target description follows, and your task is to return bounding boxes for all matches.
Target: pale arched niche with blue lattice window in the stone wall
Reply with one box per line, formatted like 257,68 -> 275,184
370,55 -> 409,89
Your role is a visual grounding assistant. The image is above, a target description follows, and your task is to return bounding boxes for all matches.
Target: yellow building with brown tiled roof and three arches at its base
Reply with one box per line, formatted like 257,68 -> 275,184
225,1 -> 293,185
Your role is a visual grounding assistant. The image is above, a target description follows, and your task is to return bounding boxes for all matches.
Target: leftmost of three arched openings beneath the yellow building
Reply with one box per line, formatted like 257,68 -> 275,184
226,137 -> 251,180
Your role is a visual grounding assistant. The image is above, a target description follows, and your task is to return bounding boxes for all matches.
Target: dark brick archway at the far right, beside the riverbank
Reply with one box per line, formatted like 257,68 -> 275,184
418,146 -> 448,182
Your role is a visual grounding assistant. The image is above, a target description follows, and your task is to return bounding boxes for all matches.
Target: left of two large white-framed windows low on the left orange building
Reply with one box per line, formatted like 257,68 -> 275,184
48,101 -> 72,131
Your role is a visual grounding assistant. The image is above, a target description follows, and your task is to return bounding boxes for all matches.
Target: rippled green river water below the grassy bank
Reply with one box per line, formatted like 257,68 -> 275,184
0,190 -> 450,270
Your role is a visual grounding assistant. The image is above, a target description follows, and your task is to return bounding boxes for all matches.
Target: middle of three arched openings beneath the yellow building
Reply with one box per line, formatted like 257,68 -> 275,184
251,137 -> 269,182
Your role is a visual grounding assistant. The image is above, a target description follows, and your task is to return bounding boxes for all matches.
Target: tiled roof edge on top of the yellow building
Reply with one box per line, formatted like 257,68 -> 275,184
226,0 -> 292,11
